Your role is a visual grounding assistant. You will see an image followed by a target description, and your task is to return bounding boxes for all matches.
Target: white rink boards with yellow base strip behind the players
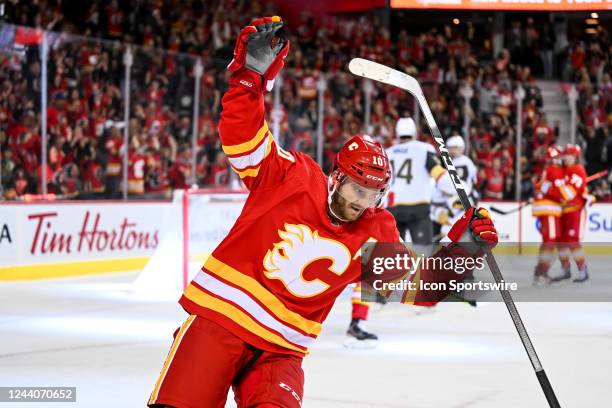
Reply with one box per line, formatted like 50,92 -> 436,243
0,200 -> 612,280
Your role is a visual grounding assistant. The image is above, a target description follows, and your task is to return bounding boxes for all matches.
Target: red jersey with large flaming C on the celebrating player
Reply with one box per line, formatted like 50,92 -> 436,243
180,81 -> 466,356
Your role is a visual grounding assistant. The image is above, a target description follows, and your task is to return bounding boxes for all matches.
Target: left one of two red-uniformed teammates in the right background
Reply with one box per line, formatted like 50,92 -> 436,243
532,146 -> 567,285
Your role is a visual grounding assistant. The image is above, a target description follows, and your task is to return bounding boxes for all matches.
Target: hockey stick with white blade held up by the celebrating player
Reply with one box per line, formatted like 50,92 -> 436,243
349,58 -> 561,408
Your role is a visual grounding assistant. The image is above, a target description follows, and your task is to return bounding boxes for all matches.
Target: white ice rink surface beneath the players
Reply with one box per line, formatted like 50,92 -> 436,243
0,260 -> 612,408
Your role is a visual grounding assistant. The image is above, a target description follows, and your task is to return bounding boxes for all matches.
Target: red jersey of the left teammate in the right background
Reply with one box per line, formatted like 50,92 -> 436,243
532,164 -> 568,217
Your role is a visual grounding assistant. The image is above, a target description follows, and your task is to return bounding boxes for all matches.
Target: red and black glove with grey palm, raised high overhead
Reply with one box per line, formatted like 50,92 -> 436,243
227,16 -> 290,92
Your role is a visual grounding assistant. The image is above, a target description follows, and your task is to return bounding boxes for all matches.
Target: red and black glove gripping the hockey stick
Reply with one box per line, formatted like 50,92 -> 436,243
447,207 -> 498,248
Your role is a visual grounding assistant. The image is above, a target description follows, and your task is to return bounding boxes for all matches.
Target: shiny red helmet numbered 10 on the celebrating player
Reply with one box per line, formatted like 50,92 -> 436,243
336,135 -> 391,190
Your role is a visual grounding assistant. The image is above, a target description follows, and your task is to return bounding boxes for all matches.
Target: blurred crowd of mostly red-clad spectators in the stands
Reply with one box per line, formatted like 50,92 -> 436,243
0,0 -> 612,199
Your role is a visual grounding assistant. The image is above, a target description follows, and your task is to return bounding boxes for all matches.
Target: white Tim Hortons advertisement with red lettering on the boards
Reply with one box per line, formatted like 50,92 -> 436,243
0,202 -> 171,279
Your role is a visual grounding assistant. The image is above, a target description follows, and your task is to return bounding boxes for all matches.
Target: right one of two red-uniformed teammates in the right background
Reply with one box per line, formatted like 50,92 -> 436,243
552,144 -> 593,282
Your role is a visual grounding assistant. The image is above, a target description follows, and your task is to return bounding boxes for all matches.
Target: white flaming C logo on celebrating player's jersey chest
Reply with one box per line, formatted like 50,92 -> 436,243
263,224 -> 351,297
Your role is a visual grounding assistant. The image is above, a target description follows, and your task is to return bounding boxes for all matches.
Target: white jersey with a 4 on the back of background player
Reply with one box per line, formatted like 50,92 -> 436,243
386,140 -> 446,205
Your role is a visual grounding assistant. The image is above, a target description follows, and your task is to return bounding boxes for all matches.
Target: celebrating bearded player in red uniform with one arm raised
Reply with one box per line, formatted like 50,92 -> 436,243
148,17 -> 497,408
